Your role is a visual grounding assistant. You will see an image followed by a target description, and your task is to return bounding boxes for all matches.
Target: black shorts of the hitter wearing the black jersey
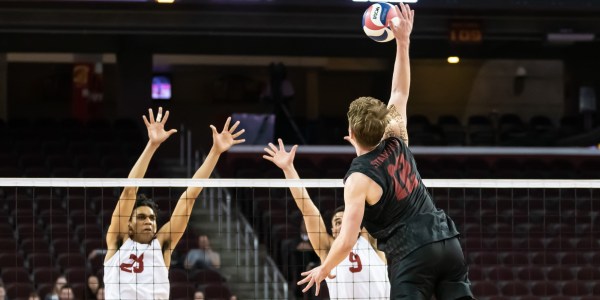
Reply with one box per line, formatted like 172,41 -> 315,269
388,238 -> 474,300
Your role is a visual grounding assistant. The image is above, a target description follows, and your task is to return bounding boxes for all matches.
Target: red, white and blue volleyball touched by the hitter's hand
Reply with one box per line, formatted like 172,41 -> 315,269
363,3 -> 398,43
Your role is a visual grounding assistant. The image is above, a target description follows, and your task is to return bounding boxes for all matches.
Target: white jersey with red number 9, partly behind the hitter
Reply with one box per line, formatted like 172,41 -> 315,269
325,236 -> 390,299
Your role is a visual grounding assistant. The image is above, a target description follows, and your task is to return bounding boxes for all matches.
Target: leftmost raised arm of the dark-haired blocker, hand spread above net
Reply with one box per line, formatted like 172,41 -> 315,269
105,107 -> 177,261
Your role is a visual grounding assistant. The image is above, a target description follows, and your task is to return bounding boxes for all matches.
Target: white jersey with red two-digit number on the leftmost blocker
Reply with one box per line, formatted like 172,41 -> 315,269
104,239 -> 170,300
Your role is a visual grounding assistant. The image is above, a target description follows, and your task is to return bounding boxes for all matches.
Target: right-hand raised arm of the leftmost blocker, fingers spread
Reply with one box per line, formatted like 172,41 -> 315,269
157,117 -> 246,266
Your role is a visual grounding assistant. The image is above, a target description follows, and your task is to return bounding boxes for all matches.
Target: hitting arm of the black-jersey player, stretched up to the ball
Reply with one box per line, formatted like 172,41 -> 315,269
384,3 -> 415,144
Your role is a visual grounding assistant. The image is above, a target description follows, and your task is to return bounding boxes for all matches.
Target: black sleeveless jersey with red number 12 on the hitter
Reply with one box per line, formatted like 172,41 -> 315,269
344,137 -> 458,263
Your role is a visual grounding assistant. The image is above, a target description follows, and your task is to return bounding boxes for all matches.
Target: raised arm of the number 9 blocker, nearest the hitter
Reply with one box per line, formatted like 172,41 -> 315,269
263,139 -> 333,261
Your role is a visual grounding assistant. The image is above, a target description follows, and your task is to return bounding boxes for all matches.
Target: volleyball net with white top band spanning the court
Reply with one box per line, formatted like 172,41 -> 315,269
0,178 -> 600,299
